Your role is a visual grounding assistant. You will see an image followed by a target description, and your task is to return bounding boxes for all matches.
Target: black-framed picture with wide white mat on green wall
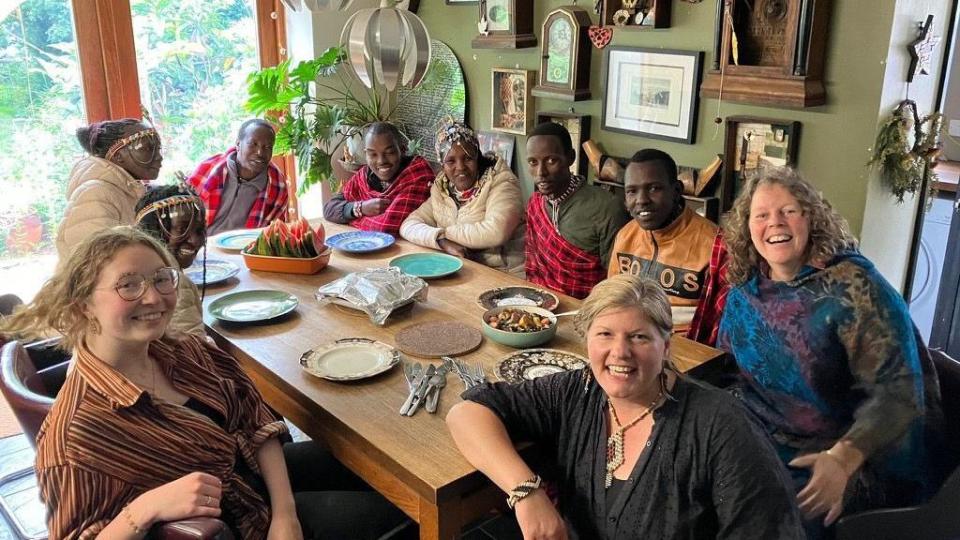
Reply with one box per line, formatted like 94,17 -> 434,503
601,47 -> 703,144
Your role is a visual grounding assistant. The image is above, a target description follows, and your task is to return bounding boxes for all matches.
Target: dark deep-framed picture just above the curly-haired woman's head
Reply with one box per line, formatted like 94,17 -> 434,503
720,116 -> 800,211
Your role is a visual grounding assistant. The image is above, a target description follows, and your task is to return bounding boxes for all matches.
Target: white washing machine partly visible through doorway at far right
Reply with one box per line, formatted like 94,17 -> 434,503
910,193 -> 953,343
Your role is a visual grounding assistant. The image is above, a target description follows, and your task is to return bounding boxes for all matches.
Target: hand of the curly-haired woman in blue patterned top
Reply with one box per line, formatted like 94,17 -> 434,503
789,452 -> 850,527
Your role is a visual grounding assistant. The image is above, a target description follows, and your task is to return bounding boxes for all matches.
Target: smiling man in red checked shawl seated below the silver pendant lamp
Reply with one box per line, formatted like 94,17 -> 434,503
323,122 -> 435,236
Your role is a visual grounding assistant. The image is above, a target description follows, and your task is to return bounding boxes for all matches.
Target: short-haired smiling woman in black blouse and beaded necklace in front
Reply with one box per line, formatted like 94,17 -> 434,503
447,275 -> 804,539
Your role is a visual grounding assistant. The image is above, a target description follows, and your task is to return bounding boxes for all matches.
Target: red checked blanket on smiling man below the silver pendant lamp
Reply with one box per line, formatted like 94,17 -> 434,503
343,156 -> 436,236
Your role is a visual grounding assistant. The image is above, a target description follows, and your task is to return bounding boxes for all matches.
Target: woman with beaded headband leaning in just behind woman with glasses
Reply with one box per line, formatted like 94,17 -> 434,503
136,185 -> 207,336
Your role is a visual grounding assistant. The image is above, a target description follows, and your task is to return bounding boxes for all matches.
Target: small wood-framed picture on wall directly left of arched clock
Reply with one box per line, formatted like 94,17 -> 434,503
490,68 -> 536,135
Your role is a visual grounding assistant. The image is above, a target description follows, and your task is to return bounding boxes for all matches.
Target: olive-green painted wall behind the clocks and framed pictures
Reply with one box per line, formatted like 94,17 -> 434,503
418,0 -> 895,233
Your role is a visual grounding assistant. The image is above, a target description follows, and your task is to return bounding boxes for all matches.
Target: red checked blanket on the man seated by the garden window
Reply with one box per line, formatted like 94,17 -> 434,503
187,148 -> 289,229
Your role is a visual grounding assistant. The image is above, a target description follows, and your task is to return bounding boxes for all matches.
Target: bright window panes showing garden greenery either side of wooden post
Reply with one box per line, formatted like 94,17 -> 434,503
0,0 -> 259,297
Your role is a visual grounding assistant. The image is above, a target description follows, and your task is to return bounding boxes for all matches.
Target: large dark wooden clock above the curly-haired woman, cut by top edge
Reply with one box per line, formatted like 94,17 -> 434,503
700,0 -> 830,108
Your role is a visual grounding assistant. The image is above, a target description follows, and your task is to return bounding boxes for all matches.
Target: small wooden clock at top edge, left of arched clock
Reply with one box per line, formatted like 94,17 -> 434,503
471,0 -> 537,49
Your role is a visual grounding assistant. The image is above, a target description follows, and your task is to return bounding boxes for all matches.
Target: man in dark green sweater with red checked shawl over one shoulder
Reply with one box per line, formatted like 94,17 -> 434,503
526,122 -> 630,298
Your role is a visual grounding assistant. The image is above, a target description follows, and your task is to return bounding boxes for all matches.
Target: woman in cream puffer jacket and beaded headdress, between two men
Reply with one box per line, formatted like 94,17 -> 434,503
400,118 -> 526,278
